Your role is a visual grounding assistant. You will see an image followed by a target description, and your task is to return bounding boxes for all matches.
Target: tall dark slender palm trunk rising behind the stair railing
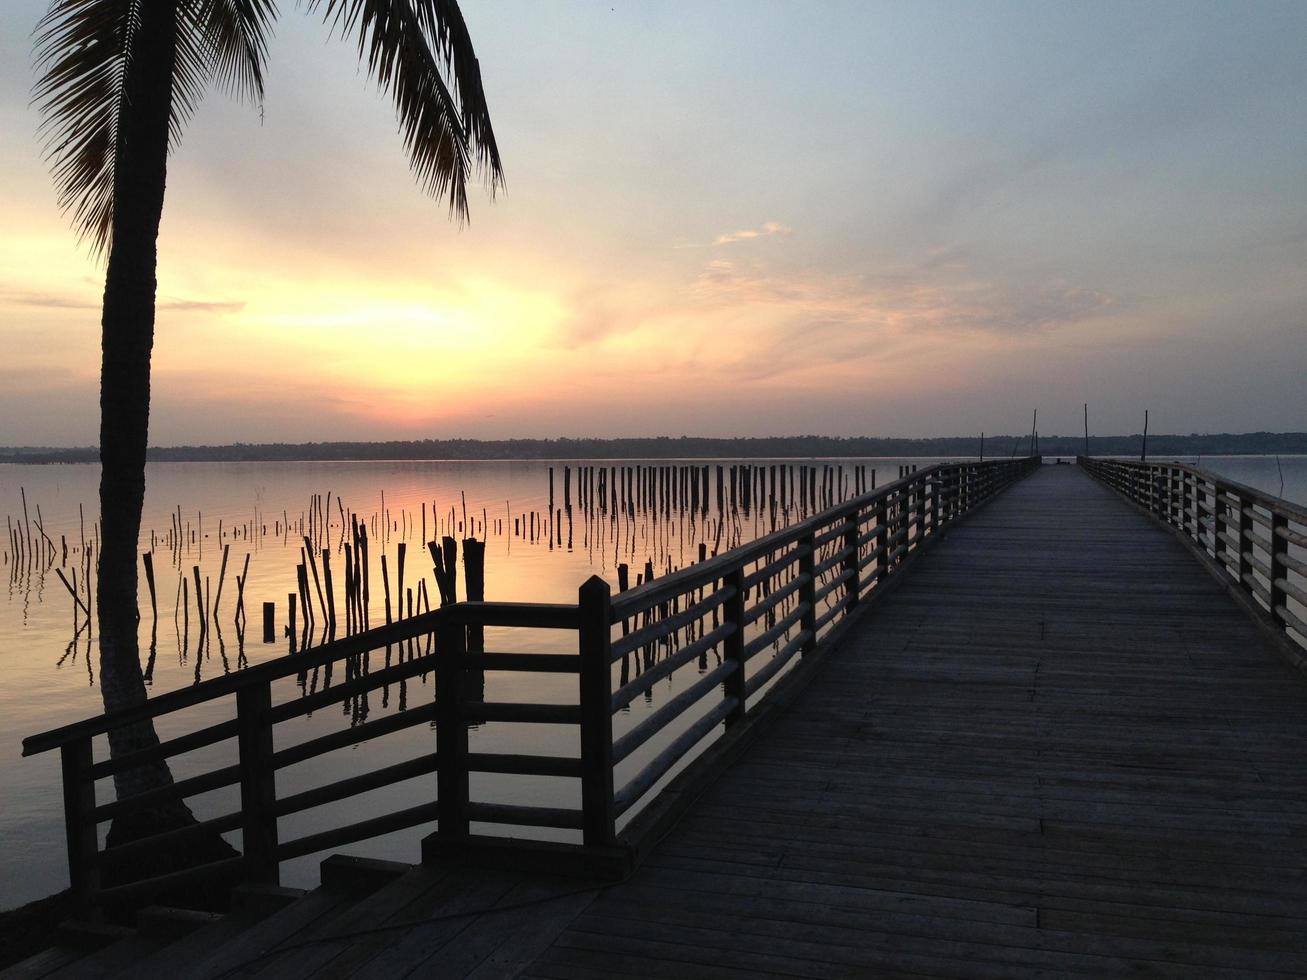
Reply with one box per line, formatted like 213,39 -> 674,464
97,0 -> 190,839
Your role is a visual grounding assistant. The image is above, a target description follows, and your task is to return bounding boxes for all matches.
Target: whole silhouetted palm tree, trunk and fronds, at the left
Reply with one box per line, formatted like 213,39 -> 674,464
34,0 -> 503,839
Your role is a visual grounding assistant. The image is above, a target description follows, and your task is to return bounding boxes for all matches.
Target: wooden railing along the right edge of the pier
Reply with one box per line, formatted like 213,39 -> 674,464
1077,456 -> 1307,645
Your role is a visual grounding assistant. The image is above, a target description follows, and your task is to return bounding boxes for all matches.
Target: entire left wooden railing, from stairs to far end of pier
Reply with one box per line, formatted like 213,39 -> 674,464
22,457 -> 1039,904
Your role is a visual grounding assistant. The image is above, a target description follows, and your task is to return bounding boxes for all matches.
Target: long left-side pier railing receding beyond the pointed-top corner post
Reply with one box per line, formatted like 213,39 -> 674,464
601,457 -> 1040,815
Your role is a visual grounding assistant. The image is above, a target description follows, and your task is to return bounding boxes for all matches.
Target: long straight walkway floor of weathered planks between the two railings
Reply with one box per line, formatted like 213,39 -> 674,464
524,466 -> 1307,980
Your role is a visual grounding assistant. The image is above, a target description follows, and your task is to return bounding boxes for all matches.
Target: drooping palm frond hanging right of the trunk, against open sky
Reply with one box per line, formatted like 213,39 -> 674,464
308,0 -> 503,221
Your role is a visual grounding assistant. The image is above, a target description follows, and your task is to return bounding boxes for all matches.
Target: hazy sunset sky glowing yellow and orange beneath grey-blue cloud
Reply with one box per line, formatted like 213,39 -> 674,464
0,0 -> 1307,446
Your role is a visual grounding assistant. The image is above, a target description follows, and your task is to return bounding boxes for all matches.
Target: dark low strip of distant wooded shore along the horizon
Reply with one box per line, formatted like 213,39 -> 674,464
0,433 -> 1307,464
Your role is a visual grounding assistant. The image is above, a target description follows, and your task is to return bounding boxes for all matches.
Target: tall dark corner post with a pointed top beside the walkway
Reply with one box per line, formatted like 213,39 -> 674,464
578,575 -> 617,847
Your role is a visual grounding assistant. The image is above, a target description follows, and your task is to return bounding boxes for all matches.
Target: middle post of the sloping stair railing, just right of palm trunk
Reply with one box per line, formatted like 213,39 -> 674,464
237,681 -> 280,885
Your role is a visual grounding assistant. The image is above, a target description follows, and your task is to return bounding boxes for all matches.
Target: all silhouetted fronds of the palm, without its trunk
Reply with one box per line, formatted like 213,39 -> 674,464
34,0 -> 503,252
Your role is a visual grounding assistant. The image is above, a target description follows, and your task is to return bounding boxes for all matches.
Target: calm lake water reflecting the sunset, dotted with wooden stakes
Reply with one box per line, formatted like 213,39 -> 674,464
0,456 -> 1307,908
